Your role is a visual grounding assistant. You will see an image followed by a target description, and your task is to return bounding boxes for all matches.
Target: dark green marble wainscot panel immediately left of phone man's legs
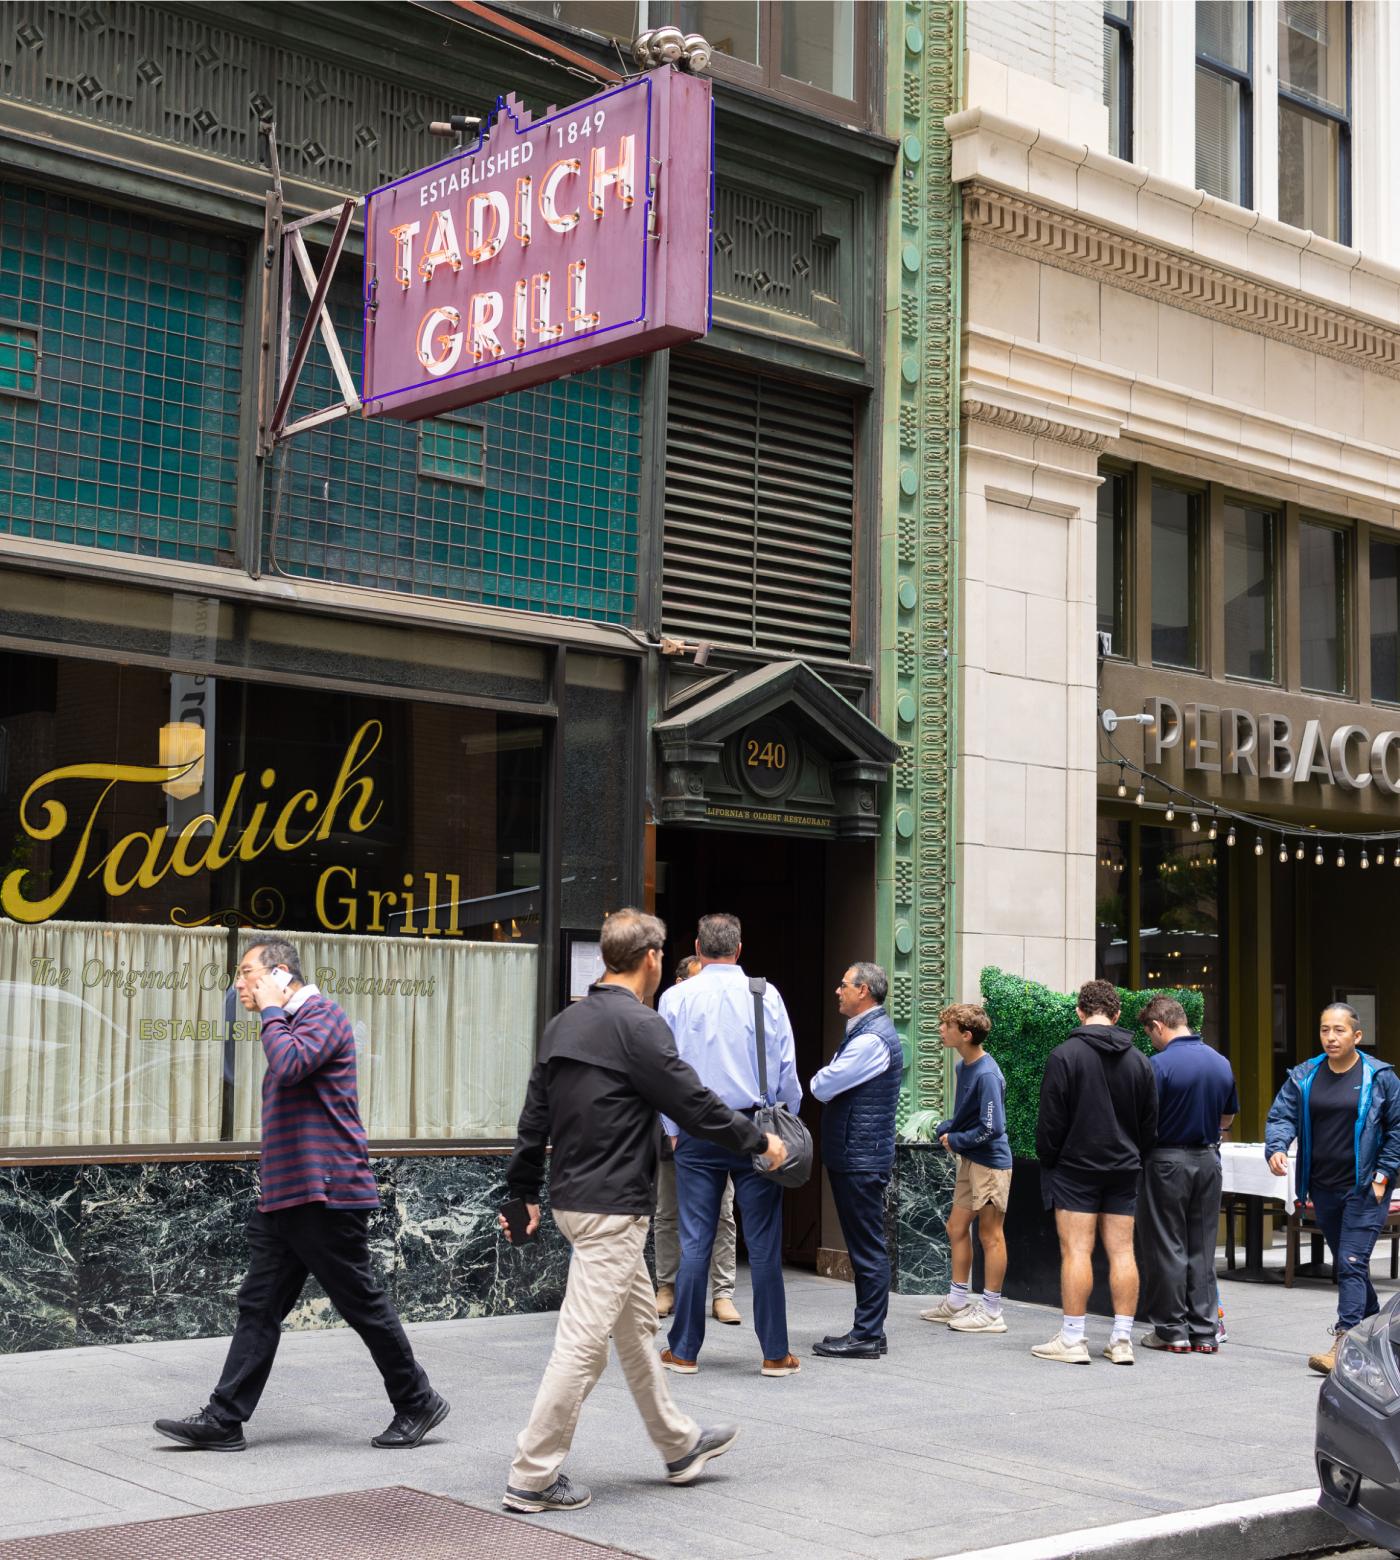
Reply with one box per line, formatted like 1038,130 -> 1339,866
76,1161 -> 258,1343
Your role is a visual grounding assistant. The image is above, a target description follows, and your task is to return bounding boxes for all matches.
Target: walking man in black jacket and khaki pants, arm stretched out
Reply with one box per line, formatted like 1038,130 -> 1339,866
501,909 -> 787,1512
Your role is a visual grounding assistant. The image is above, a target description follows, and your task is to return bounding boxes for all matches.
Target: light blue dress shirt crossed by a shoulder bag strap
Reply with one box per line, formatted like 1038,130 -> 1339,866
657,964 -> 802,1137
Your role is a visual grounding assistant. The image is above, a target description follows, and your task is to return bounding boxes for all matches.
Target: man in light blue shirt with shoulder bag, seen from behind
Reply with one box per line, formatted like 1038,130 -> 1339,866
657,914 -> 802,1376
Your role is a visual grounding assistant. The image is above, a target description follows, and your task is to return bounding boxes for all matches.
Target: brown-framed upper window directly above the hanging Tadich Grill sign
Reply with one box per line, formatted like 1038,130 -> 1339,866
512,0 -> 879,115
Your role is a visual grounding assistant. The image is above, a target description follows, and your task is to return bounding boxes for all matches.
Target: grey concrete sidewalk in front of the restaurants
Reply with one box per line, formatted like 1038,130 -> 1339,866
0,1264 -> 1373,1560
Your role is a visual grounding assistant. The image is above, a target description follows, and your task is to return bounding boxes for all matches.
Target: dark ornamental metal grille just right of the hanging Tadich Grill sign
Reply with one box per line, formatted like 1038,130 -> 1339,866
715,184 -> 837,320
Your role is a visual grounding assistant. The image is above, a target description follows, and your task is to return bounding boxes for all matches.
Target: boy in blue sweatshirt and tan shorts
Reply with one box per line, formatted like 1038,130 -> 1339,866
919,1002 -> 1011,1332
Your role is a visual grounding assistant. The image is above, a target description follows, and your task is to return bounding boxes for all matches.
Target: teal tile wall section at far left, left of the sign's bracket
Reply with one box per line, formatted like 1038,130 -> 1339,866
0,184 -> 243,563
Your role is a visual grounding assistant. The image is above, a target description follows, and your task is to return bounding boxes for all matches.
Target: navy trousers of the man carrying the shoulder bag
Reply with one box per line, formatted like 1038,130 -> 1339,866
668,1137 -> 788,1360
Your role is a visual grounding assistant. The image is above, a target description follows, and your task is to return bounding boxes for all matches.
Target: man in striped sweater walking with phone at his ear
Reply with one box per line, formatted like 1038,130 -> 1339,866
156,938 -> 448,1452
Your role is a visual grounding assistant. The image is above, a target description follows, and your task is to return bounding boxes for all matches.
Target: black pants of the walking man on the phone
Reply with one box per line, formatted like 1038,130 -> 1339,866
209,1203 -> 432,1424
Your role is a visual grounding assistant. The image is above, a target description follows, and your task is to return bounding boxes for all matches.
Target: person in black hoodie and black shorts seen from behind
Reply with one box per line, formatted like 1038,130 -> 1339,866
1030,980 -> 1157,1365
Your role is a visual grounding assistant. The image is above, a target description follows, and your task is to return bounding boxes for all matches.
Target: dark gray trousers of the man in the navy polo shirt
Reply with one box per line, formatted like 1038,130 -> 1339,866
1138,1148 -> 1221,1343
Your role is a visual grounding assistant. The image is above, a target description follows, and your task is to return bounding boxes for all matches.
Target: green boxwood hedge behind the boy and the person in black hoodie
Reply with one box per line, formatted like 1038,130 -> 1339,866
982,966 -> 1205,1159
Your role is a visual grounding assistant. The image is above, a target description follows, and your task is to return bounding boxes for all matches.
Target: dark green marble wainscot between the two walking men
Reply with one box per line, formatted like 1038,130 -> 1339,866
393,1154 -> 568,1321
